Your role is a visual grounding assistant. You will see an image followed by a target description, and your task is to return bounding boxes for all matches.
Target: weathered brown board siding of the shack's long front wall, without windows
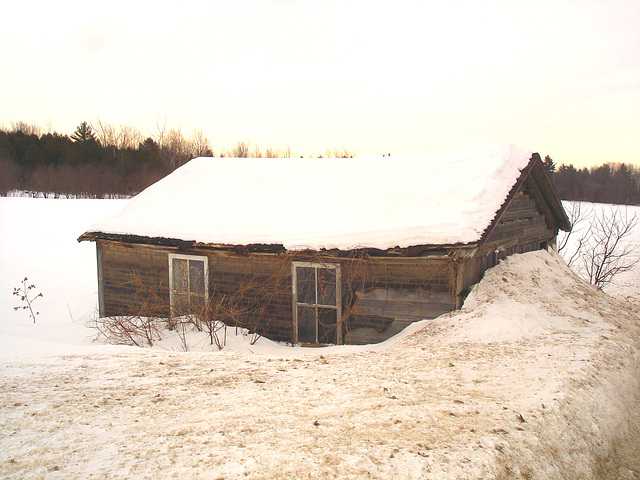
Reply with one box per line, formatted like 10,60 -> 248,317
97,244 -> 455,343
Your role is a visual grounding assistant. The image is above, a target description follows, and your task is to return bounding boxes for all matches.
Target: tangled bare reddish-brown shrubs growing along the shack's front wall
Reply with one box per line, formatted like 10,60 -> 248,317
93,250 -> 460,351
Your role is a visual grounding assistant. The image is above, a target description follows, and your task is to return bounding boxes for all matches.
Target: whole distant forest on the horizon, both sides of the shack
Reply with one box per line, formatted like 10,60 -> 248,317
0,120 -> 640,205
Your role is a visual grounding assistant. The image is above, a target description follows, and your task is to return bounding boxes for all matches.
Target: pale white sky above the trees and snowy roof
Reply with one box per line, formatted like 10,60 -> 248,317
0,0 -> 640,166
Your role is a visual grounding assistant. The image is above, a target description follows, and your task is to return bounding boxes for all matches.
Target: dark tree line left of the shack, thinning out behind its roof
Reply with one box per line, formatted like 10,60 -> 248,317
0,120 -> 310,198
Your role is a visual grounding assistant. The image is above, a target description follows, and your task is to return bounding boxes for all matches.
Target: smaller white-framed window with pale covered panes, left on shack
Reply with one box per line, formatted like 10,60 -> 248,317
169,253 -> 209,317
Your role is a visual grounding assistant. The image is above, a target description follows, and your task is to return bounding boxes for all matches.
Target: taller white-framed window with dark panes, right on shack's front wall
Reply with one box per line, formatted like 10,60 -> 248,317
291,262 -> 342,344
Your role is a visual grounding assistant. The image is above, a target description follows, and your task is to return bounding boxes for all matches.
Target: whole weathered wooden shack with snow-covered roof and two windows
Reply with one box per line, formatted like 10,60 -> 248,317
78,144 -> 570,345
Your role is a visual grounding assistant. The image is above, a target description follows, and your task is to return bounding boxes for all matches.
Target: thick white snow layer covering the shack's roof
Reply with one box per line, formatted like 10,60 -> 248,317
88,144 -> 532,250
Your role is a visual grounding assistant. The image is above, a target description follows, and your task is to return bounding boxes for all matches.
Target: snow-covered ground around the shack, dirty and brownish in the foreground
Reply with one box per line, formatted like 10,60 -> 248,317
0,198 -> 640,479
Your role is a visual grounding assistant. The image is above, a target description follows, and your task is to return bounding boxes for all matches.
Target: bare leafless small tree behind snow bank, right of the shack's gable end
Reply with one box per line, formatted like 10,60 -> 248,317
558,202 -> 640,288
